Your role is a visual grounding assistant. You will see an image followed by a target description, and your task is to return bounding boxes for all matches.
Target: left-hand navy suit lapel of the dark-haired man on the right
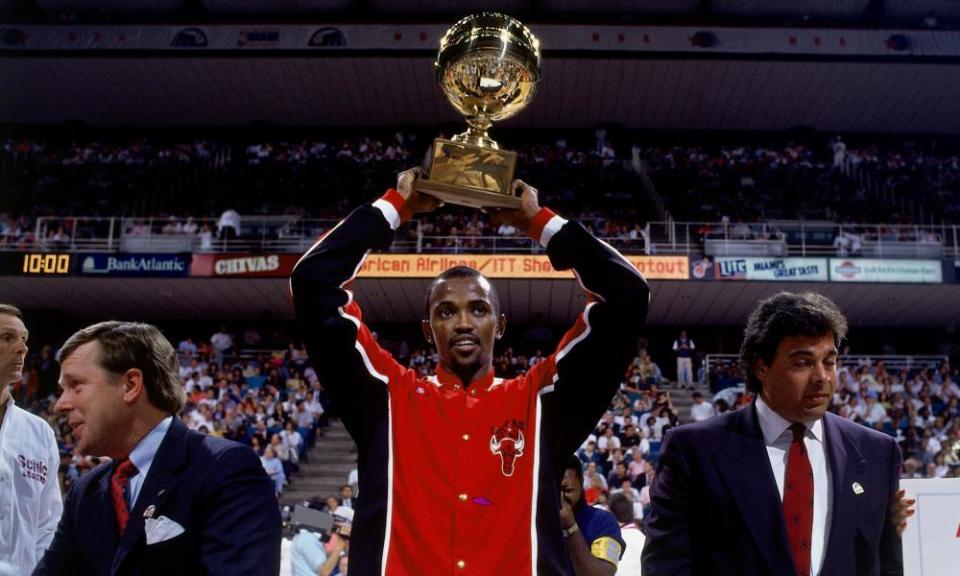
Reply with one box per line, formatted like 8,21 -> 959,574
714,405 -> 794,574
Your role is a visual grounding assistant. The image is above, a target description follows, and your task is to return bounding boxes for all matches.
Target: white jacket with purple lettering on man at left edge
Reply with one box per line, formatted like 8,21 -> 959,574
0,396 -> 63,576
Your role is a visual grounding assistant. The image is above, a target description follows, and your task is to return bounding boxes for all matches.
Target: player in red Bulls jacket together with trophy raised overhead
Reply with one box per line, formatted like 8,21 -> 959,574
291,13 -> 650,576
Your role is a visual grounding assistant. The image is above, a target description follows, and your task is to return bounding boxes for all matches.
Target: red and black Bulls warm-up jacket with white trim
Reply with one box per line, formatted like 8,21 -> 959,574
291,190 -> 650,576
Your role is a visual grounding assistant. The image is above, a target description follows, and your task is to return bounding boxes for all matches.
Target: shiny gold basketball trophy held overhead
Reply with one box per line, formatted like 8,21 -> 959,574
414,12 -> 540,208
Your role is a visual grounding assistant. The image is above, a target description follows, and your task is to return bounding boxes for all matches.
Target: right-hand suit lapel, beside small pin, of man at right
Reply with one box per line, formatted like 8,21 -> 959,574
823,412 -> 864,574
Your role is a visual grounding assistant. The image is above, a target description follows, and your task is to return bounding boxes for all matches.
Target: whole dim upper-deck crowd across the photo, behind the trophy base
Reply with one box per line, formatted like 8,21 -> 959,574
0,130 -> 960,253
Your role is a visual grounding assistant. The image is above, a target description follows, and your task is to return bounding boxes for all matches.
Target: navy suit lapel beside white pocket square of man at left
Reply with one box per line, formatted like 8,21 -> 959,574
111,417 -> 187,574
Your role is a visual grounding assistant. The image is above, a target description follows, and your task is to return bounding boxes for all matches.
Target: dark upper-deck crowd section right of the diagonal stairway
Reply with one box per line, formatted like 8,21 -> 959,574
641,137 -> 960,225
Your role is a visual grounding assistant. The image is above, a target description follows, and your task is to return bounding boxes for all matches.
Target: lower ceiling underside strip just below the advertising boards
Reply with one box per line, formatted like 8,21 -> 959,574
0,277 -> 960,327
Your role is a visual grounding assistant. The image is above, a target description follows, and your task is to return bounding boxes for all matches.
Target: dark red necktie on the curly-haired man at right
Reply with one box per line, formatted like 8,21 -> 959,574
783,424 -> 813,576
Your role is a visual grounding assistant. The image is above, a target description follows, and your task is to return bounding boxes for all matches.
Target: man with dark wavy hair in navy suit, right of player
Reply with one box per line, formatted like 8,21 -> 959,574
643,292 -> 902,576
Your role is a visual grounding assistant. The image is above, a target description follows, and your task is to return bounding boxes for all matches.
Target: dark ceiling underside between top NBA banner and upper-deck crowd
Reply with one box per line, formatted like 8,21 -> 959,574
0,55 -> 960,134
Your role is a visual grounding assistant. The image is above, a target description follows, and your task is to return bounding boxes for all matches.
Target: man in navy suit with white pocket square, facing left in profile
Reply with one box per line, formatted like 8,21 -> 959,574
34,322 -> 280,576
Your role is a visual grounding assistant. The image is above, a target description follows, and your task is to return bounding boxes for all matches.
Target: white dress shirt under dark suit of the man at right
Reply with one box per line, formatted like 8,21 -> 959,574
757,397 -> 833,575
